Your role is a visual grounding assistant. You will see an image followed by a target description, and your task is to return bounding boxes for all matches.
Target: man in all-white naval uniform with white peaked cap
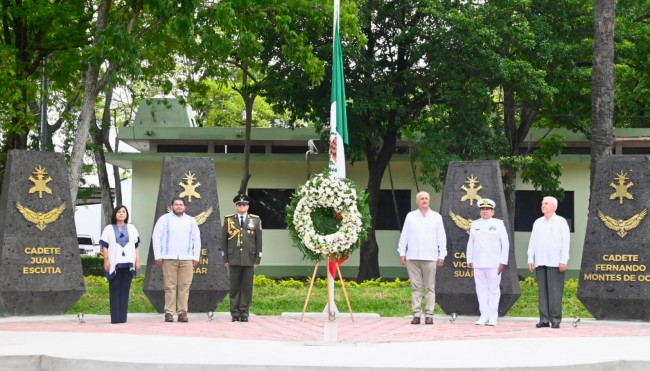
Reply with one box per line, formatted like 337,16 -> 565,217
466,198 -> 510,326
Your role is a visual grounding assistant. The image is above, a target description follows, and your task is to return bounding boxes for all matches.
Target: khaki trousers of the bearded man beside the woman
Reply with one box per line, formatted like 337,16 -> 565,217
163,259 -> 194,314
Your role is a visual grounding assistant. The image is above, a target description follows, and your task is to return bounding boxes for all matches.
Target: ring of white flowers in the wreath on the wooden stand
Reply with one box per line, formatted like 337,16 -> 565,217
293,176 -> 362,255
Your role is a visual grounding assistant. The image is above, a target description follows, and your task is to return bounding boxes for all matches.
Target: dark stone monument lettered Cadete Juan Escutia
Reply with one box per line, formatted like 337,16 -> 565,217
0,150 -> 86,316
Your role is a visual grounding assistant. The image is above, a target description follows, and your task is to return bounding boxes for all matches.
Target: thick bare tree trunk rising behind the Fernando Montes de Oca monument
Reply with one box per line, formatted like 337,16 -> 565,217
589,0 -> 616,189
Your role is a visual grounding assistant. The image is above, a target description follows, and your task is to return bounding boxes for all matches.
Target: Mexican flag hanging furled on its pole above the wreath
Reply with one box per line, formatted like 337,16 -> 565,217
329,0 -> 348,178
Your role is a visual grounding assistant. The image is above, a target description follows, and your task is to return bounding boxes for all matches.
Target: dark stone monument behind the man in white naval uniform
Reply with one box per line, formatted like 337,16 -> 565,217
436,161 -> 521,316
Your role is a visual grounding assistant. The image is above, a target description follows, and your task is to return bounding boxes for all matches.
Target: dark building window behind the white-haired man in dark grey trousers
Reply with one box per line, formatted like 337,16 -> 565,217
515,191 -> 574,232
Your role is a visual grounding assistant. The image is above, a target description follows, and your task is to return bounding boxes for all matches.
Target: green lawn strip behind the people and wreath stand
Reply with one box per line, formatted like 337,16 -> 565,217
68,276 -> 591,318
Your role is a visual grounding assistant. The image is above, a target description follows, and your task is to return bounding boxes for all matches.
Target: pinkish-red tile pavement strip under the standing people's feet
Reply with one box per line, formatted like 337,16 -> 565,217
0,314 -> 650,343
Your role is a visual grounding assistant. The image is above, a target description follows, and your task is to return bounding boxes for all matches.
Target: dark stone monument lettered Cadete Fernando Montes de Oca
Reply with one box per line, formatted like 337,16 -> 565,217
578,156 -> 650,321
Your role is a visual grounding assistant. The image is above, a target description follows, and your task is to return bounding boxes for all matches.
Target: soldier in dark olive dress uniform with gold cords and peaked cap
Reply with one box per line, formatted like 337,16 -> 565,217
221,194 -> 262,322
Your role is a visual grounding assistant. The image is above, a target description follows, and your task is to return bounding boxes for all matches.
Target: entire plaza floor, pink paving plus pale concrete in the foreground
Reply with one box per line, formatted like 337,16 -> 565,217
0,313 -> 650,371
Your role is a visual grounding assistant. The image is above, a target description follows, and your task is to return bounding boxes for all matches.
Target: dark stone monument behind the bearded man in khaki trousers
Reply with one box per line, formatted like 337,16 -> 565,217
143,157 -> 229,313
